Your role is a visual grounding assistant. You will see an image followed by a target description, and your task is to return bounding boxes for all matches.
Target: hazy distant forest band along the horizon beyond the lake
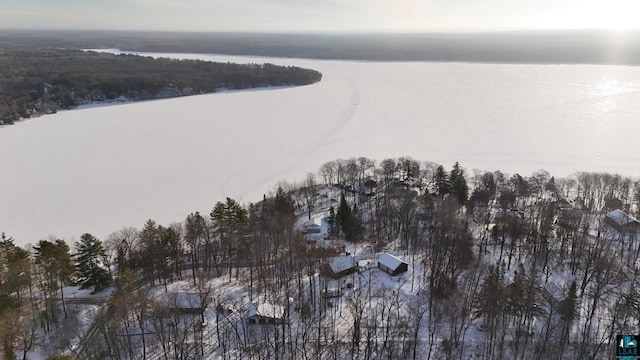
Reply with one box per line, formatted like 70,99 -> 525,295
0,30 -> 640,65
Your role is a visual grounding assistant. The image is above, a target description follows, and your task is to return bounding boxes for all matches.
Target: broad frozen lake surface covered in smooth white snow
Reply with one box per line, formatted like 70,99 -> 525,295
0,50 -> 640,244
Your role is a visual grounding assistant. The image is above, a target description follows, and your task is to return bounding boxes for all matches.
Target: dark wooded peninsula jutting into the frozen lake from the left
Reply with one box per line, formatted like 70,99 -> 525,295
0,47 -> 322,124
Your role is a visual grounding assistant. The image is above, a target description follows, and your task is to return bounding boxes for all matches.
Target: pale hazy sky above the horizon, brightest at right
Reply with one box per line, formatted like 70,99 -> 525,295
0,0 -> 640,32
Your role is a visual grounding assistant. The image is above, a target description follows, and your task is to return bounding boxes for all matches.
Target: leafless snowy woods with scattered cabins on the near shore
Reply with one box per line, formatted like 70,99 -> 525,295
0,157 -> 640,359
